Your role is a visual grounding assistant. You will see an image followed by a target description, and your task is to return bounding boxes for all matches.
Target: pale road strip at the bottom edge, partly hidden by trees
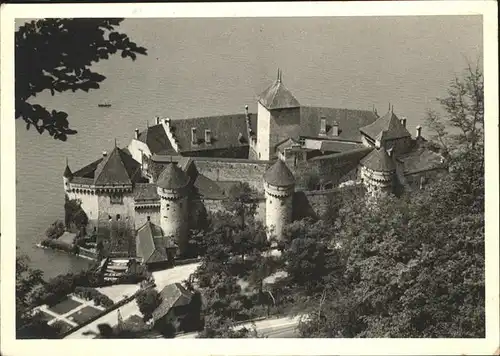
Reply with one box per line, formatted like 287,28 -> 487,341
176,316 -> 301,339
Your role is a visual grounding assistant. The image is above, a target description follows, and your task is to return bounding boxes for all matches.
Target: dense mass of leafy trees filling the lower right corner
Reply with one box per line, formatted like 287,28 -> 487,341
301,143 -> 485,337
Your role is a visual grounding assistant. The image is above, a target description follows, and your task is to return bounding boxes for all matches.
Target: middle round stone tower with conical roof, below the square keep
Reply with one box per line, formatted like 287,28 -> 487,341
264,159 -> 295,239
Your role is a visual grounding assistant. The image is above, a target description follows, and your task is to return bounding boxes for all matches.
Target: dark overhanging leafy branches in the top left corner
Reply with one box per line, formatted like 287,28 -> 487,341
15,18 -> 147,141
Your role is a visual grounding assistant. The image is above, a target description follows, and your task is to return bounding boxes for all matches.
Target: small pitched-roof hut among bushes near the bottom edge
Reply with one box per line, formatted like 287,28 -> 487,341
153,283 -> 193,330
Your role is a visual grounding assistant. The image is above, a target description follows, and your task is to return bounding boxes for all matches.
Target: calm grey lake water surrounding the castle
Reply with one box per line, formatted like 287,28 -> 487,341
16,16 -> 482,277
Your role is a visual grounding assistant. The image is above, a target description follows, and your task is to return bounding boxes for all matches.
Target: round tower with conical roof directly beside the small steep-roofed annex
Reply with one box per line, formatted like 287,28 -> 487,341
156,162 -> 189,254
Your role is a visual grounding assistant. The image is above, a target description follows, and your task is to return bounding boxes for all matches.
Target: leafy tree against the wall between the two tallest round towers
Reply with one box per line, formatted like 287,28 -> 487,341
222,182 -> 257,227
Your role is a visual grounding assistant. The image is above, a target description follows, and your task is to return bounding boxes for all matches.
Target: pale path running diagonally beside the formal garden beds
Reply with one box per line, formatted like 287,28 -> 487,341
65,263 -> 199,339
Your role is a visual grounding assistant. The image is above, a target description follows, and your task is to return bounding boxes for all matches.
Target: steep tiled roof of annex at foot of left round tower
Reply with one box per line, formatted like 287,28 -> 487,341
136,221 -> 176,263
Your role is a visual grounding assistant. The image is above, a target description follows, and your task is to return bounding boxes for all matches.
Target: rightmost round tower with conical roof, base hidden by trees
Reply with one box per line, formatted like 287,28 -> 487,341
361,147 -> 396,197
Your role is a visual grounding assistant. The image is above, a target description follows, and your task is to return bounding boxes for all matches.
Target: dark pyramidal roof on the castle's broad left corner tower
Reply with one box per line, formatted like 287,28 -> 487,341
94,147 -> 141,185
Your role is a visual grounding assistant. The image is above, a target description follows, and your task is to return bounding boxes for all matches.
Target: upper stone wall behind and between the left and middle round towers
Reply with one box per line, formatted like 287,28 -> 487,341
195,160 -> 268,193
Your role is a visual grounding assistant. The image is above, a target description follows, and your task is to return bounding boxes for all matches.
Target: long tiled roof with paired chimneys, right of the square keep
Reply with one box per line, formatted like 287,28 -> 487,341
300,106 -> 377,142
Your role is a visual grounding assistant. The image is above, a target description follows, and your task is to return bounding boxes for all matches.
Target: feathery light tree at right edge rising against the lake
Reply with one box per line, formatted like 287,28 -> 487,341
426,63 -> 484,152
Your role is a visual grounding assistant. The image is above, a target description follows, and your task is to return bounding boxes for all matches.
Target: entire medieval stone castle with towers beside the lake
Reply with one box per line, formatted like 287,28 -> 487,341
63,71 -> 445,264
